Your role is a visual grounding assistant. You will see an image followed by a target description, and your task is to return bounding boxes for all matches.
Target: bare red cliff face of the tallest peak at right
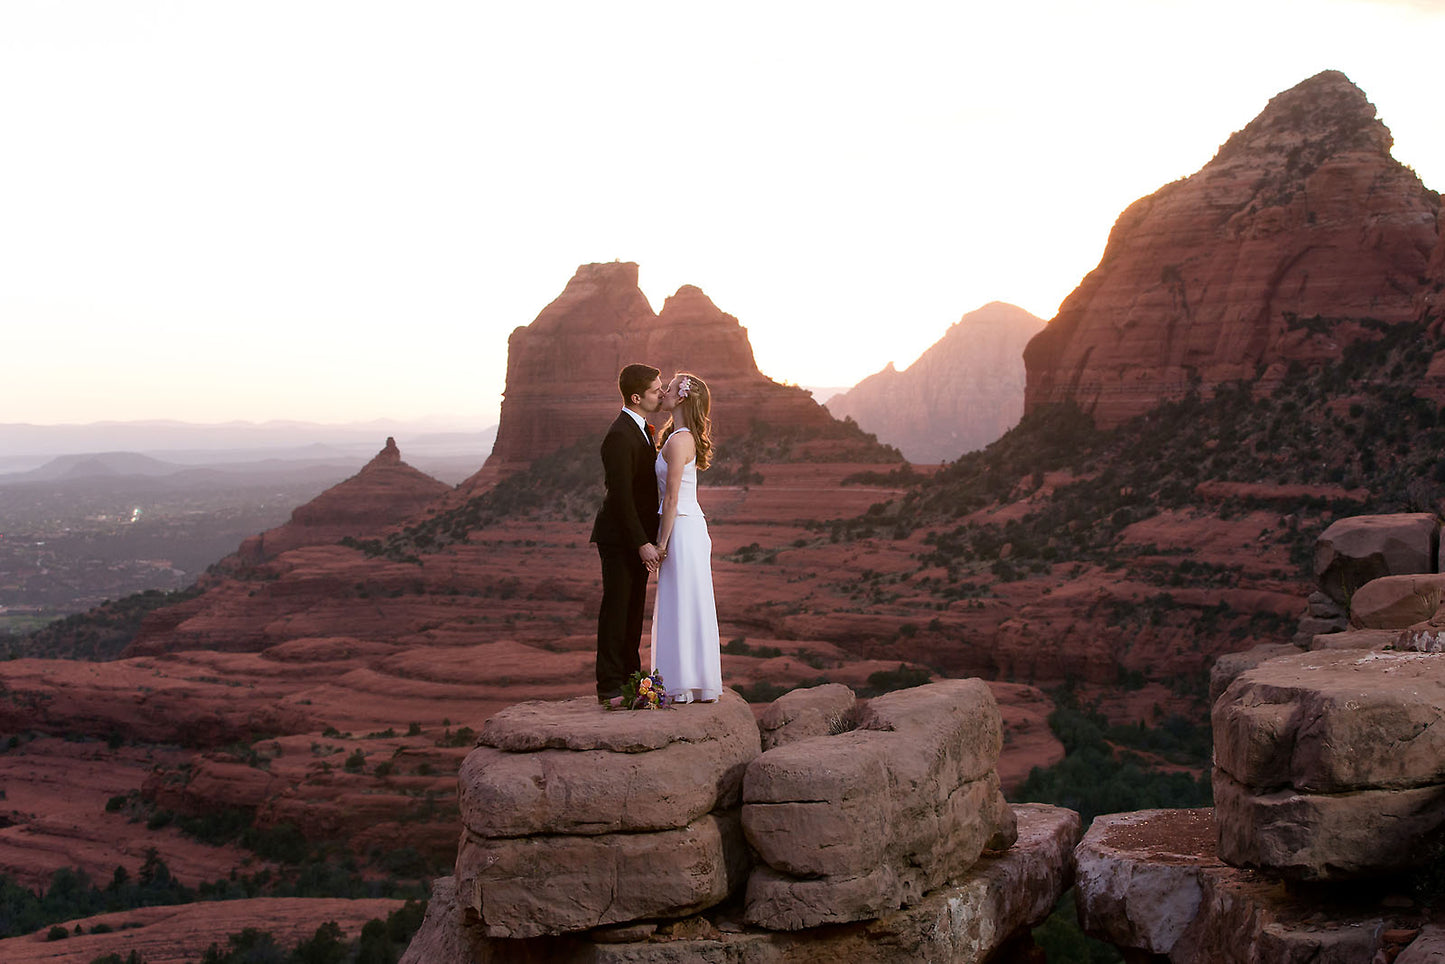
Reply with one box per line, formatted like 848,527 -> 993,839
1025,71 -> 1442,428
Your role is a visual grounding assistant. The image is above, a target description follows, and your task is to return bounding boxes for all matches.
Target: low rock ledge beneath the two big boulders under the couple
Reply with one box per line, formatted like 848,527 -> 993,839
402,804 -> 1079,964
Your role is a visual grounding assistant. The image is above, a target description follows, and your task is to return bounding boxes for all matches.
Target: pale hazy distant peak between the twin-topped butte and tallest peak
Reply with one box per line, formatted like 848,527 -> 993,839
827,301 -> 1043,462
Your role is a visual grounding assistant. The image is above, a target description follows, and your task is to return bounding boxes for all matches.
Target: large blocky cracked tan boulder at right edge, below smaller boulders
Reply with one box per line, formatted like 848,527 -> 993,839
1212,650 -> 1445,880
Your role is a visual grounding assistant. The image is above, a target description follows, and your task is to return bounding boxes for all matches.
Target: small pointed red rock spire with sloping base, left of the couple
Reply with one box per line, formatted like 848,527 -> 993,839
236,438 -> 451,565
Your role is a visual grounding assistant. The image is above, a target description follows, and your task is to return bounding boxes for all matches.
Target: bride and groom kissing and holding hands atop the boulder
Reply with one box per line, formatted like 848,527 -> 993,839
591,364 -> 723,705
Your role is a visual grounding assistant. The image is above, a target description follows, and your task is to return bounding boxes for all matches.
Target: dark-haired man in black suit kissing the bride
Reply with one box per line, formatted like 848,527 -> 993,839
591,364 -> 662,702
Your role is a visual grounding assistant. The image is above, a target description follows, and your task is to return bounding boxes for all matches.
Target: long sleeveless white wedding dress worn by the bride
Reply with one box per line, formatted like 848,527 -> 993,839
652,428 -> 723,702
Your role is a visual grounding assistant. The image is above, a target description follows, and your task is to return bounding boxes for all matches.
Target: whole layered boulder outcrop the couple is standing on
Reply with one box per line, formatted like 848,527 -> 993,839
421,679 -> 1078,963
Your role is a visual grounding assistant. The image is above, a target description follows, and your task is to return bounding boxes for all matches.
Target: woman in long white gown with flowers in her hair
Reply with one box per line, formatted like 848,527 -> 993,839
652,371 -> 723,702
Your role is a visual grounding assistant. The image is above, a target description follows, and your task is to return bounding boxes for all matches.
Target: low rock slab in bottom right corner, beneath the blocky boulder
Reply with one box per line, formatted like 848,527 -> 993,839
1074,809 -> 1442,964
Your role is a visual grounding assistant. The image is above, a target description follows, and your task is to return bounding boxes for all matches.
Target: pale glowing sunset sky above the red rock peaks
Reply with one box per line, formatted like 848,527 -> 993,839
0,0 -> 1445,423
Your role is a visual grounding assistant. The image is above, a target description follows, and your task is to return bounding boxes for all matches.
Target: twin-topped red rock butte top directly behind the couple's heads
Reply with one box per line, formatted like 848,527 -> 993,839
484,262 -> 832,474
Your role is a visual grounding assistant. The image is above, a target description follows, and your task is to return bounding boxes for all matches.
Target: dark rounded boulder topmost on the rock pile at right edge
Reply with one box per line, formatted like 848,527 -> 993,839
1315,512 -> 1441,608
